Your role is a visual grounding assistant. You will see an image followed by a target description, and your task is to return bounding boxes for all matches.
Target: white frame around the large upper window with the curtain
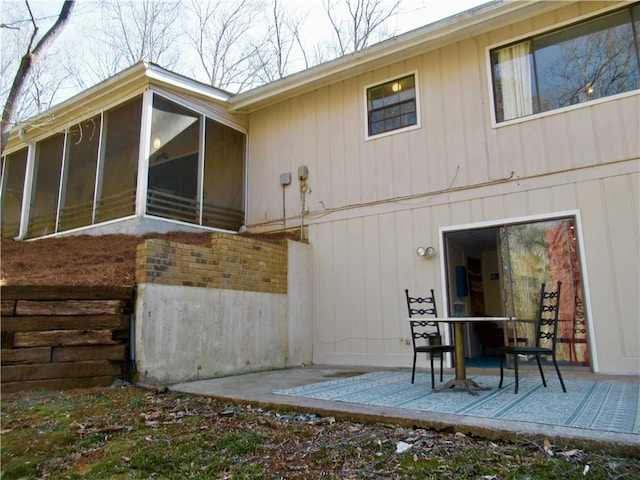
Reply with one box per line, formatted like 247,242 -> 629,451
485,2 -> 640,129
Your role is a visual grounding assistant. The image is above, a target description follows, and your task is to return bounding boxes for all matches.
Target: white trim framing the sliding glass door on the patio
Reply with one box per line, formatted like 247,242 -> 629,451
438,210 -> 600,373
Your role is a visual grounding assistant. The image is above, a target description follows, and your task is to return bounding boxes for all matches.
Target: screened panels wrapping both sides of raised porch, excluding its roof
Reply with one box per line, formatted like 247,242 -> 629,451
0,91 -> 246,239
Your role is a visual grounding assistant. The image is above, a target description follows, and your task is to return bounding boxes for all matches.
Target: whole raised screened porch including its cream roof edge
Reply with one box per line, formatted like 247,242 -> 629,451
0,63 -> 246,240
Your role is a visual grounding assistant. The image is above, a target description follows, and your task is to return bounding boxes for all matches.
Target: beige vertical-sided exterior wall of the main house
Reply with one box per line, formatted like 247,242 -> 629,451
242,2 -> 640,374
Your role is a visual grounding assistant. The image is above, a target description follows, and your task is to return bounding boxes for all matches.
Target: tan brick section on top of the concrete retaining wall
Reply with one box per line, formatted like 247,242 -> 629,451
136,233 -> 287,294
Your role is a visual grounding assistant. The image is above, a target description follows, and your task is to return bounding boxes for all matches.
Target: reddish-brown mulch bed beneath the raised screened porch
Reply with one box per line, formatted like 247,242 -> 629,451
0,232 -> 297,287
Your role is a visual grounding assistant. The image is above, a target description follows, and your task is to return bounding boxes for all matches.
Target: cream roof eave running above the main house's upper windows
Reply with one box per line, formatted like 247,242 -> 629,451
229,0 -> 573,113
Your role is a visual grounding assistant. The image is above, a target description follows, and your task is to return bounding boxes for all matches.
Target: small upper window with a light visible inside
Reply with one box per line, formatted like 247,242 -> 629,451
367,74 -> 418,137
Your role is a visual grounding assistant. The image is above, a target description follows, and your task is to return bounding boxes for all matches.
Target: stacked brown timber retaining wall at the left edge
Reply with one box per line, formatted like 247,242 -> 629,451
0,286 -> 133,392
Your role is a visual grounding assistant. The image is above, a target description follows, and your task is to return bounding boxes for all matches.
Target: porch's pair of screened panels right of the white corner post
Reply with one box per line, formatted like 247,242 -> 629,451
147,95 -> 245,231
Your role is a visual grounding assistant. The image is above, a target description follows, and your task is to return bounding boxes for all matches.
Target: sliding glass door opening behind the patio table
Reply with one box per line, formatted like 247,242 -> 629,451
443,216 -> 589,367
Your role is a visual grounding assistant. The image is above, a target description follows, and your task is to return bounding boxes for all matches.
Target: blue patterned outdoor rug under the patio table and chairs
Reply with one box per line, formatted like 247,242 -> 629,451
273,371 -> 640,435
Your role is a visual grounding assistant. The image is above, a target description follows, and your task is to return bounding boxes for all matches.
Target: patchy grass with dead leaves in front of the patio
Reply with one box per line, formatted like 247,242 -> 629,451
0,386 -> 640,480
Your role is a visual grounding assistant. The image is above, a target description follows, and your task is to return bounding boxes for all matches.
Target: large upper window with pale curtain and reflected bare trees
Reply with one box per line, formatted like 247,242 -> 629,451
491,3 -> 640,122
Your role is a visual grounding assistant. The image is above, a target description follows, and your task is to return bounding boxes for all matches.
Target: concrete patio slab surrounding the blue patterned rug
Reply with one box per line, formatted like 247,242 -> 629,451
170,365 -> 640,451
